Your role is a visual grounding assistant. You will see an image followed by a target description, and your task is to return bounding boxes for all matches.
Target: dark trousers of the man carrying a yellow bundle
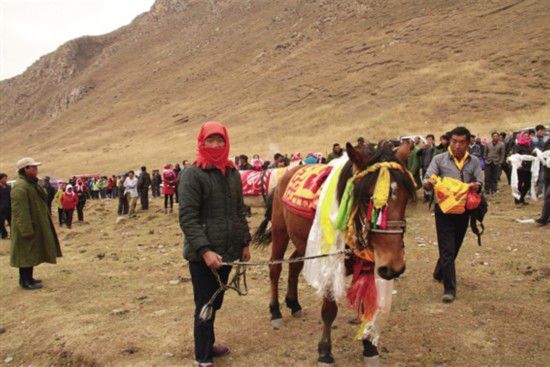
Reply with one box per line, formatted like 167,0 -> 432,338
433,205 -> 470,295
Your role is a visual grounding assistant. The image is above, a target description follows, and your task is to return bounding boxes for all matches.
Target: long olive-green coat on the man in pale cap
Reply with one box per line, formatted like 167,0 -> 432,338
10,175 -> 61,268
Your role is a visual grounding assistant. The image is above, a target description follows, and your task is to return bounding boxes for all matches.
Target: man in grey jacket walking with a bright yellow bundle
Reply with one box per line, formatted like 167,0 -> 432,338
424,127 -> 482,303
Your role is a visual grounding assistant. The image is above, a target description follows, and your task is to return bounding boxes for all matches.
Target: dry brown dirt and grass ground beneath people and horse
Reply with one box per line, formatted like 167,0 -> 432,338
0,188 -> 550,366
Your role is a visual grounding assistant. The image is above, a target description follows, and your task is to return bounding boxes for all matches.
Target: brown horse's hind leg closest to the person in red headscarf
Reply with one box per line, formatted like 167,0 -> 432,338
269,219 -> 289,329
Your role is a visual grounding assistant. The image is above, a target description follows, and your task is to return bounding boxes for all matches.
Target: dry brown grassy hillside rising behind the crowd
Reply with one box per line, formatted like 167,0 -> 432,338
0,0 -> 550,176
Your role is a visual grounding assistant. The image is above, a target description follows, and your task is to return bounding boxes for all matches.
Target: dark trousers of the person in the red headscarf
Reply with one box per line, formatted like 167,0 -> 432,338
189,261 -> 231,363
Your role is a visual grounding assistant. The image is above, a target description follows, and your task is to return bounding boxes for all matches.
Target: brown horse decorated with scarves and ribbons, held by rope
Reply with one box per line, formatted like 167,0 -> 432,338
256,143 -> 415,364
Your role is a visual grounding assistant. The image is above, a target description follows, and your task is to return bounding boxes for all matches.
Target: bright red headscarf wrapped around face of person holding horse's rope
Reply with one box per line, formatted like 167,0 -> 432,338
195,121 -> 235,175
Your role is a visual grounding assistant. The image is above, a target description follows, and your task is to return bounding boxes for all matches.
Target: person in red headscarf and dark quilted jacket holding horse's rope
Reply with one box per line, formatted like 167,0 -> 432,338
178,121 -> 250,366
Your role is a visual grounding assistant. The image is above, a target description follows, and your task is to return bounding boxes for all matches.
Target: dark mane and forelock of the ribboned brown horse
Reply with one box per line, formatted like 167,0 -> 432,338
337,141 -> 416,201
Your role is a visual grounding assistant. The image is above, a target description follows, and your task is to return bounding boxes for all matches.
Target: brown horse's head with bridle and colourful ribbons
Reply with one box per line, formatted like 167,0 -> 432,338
339,142 -> 416,280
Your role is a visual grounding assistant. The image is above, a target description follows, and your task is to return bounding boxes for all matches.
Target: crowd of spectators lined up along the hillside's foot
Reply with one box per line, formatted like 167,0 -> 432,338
0,125 -> 550,238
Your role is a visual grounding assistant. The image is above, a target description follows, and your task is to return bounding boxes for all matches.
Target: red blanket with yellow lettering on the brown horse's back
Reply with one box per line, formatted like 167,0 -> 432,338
283,164 -> 332,219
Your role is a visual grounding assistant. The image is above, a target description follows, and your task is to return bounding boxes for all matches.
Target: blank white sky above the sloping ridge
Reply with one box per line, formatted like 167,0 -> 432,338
0,0 -> 154,80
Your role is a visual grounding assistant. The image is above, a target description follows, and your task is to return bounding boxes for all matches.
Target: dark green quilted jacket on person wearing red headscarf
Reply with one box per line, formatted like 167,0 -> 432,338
178,166 -> 250,262
